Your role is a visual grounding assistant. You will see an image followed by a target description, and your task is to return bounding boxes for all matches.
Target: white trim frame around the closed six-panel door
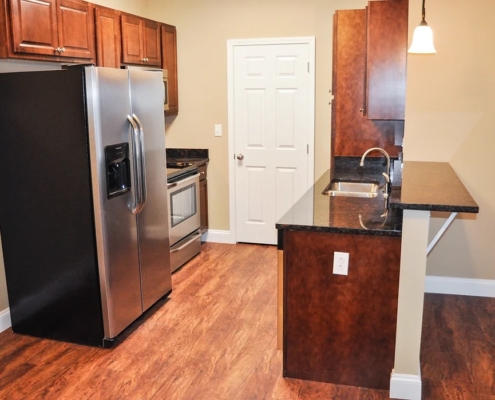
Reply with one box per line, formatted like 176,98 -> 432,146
227,36 -> 316,243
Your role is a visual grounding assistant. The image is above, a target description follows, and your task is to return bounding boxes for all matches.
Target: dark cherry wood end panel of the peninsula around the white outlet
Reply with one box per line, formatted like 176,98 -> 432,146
283,230 -> 401,390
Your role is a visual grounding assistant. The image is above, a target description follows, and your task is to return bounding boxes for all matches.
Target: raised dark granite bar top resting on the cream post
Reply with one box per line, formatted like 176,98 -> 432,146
390,161 -> 479,213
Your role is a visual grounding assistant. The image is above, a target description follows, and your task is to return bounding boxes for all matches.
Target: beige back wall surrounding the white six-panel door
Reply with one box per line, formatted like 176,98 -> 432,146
148,0 -> 367,230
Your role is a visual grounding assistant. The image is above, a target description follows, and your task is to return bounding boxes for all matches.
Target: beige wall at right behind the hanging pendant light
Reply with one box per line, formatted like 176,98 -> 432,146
404,0 -> 495,279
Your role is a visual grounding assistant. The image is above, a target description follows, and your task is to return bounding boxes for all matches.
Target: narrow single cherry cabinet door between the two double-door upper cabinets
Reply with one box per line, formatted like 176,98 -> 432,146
95,6 -> 121,68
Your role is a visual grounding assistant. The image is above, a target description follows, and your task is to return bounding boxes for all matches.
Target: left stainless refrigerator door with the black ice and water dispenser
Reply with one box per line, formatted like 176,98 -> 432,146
85,67 -> 142,338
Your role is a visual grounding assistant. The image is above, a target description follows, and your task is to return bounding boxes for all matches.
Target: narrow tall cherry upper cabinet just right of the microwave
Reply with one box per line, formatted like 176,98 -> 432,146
161,24 -> 179,116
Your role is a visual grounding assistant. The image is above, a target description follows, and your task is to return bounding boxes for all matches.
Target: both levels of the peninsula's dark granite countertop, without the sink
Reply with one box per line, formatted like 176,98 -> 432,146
276,161 -> 479,236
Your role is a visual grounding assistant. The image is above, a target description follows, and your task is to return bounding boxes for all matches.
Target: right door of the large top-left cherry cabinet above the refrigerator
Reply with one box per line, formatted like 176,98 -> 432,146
57,0 -> 95,59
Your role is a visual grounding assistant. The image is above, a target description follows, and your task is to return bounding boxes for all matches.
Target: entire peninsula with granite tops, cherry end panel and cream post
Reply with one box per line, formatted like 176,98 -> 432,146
276,161 -> 479,399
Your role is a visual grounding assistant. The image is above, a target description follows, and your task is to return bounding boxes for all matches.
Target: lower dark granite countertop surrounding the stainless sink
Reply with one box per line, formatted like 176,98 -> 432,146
276,168 -> 402,236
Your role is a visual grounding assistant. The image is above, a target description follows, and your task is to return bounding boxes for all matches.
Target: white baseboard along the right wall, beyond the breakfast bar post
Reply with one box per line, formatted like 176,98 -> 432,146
425,276 -> 495,297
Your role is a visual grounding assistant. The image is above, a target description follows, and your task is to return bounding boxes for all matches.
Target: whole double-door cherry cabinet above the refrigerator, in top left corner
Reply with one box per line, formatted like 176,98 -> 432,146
0,0 -> 95,62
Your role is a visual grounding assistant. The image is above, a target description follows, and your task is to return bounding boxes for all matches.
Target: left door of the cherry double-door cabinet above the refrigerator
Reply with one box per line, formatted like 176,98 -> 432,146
10,0 -> 59,55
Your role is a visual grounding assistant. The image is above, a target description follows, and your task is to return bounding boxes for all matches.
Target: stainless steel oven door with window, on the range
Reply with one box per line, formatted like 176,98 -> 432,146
167,173 -> 201,246
